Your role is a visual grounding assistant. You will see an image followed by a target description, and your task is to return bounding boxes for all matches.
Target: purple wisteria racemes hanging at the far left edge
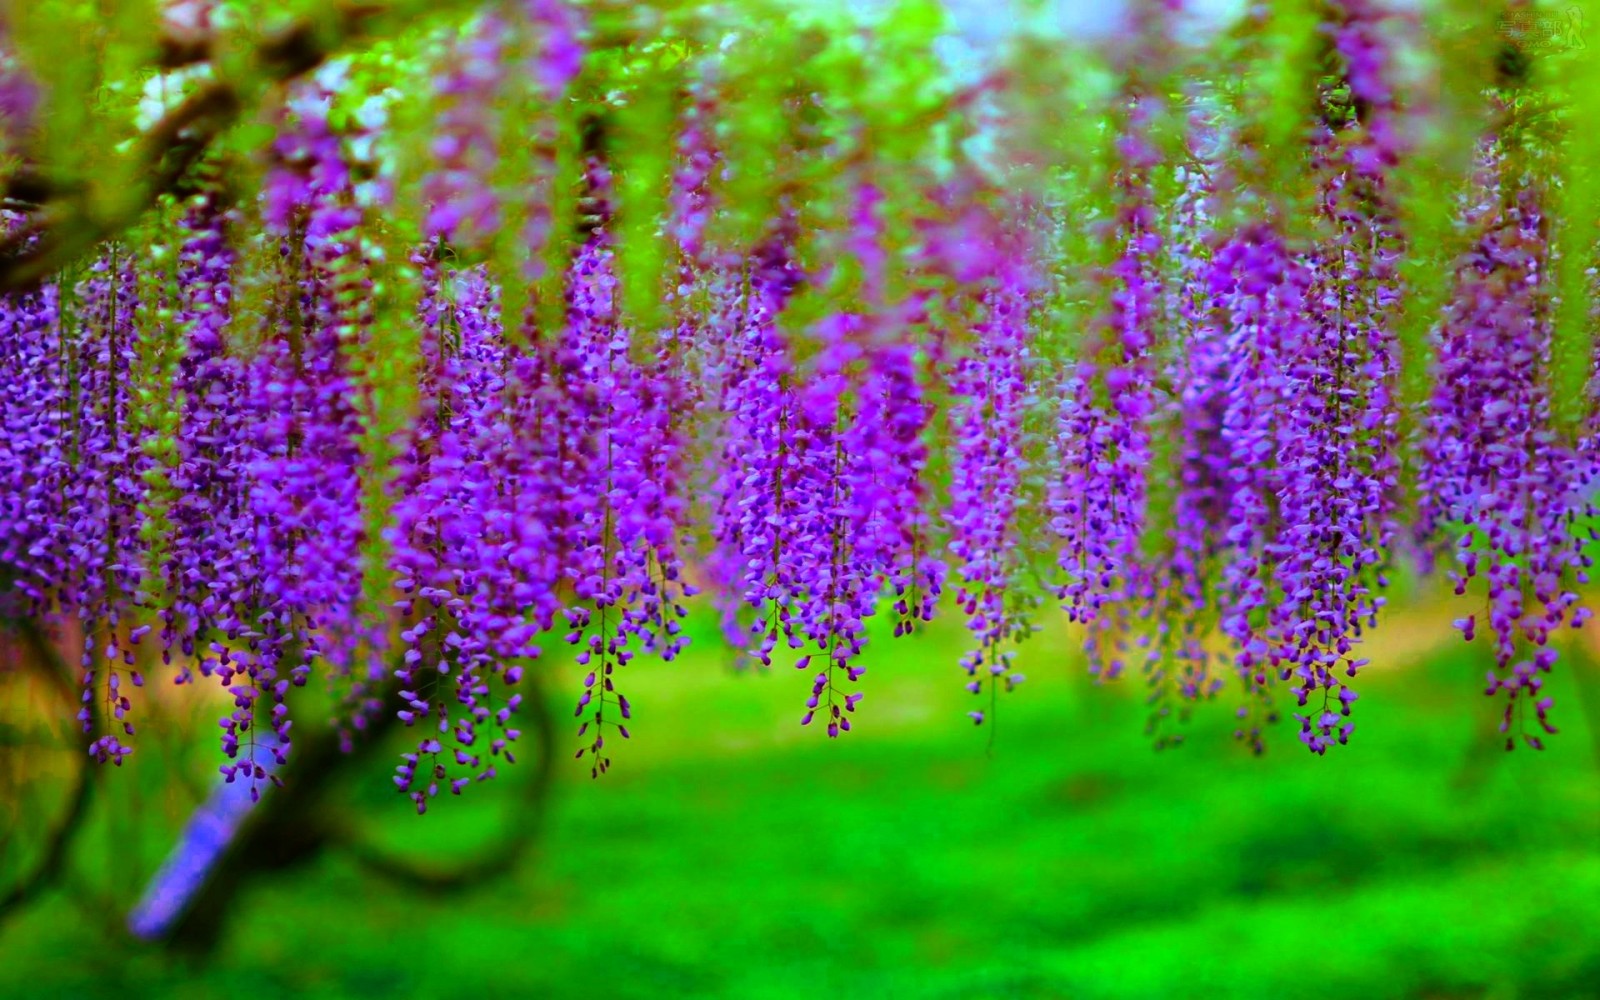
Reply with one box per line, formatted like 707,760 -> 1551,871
0,233 -> 150,765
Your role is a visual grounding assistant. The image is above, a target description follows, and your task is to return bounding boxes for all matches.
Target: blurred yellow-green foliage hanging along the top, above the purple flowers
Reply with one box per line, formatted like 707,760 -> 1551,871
6,0 -> 1600,416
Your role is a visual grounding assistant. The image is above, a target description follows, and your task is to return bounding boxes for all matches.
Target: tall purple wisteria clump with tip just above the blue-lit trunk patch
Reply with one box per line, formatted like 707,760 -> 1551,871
177,74 -> 374,794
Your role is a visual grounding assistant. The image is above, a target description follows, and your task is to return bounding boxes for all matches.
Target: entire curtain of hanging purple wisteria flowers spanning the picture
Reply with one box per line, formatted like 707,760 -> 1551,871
0,0 -> 1600,811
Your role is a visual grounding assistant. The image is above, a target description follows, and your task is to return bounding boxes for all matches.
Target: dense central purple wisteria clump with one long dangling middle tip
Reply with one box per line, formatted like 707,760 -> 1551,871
712,184 -> 944,738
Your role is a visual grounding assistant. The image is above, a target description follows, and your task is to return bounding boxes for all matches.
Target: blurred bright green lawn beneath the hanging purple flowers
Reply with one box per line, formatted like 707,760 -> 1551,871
0,604 -> 1600,998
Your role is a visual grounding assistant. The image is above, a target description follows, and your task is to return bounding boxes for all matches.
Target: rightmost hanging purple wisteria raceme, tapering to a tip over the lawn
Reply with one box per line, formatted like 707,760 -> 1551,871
1421,138 -> 1594,747
